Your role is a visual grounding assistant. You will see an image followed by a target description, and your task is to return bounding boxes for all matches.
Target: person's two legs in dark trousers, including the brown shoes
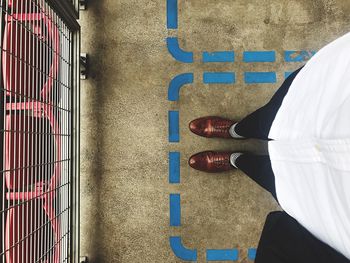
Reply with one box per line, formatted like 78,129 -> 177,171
189,68 -> 301,200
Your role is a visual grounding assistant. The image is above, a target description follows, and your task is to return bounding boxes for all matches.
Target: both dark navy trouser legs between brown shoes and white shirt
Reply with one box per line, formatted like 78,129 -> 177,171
235,68 -> 301,200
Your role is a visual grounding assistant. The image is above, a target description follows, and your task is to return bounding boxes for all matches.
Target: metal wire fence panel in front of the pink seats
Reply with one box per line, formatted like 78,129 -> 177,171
0,0 -> 80,263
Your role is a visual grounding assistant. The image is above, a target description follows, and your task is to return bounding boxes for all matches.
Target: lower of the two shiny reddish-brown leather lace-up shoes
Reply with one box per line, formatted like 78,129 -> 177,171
188,151 -> 236,173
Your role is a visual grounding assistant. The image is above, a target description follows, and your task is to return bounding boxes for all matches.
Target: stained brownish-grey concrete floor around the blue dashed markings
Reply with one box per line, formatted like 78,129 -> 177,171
80,0 -> 350,263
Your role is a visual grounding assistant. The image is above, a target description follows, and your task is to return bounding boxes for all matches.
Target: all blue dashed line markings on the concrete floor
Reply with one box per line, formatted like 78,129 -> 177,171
166,0 -> 286,261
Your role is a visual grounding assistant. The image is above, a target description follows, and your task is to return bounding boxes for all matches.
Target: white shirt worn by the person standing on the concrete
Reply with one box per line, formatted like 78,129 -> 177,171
268,33 -> 350,259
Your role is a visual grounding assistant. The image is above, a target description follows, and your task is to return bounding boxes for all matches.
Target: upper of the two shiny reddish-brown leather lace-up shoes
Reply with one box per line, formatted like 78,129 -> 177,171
189,116 -> 236,139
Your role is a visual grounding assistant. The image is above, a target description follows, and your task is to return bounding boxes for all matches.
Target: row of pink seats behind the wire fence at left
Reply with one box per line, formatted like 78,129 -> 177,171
2,1 -> 61,263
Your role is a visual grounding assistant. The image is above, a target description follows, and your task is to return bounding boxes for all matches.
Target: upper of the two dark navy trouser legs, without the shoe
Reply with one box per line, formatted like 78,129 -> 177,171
234,68 -> 301,140
